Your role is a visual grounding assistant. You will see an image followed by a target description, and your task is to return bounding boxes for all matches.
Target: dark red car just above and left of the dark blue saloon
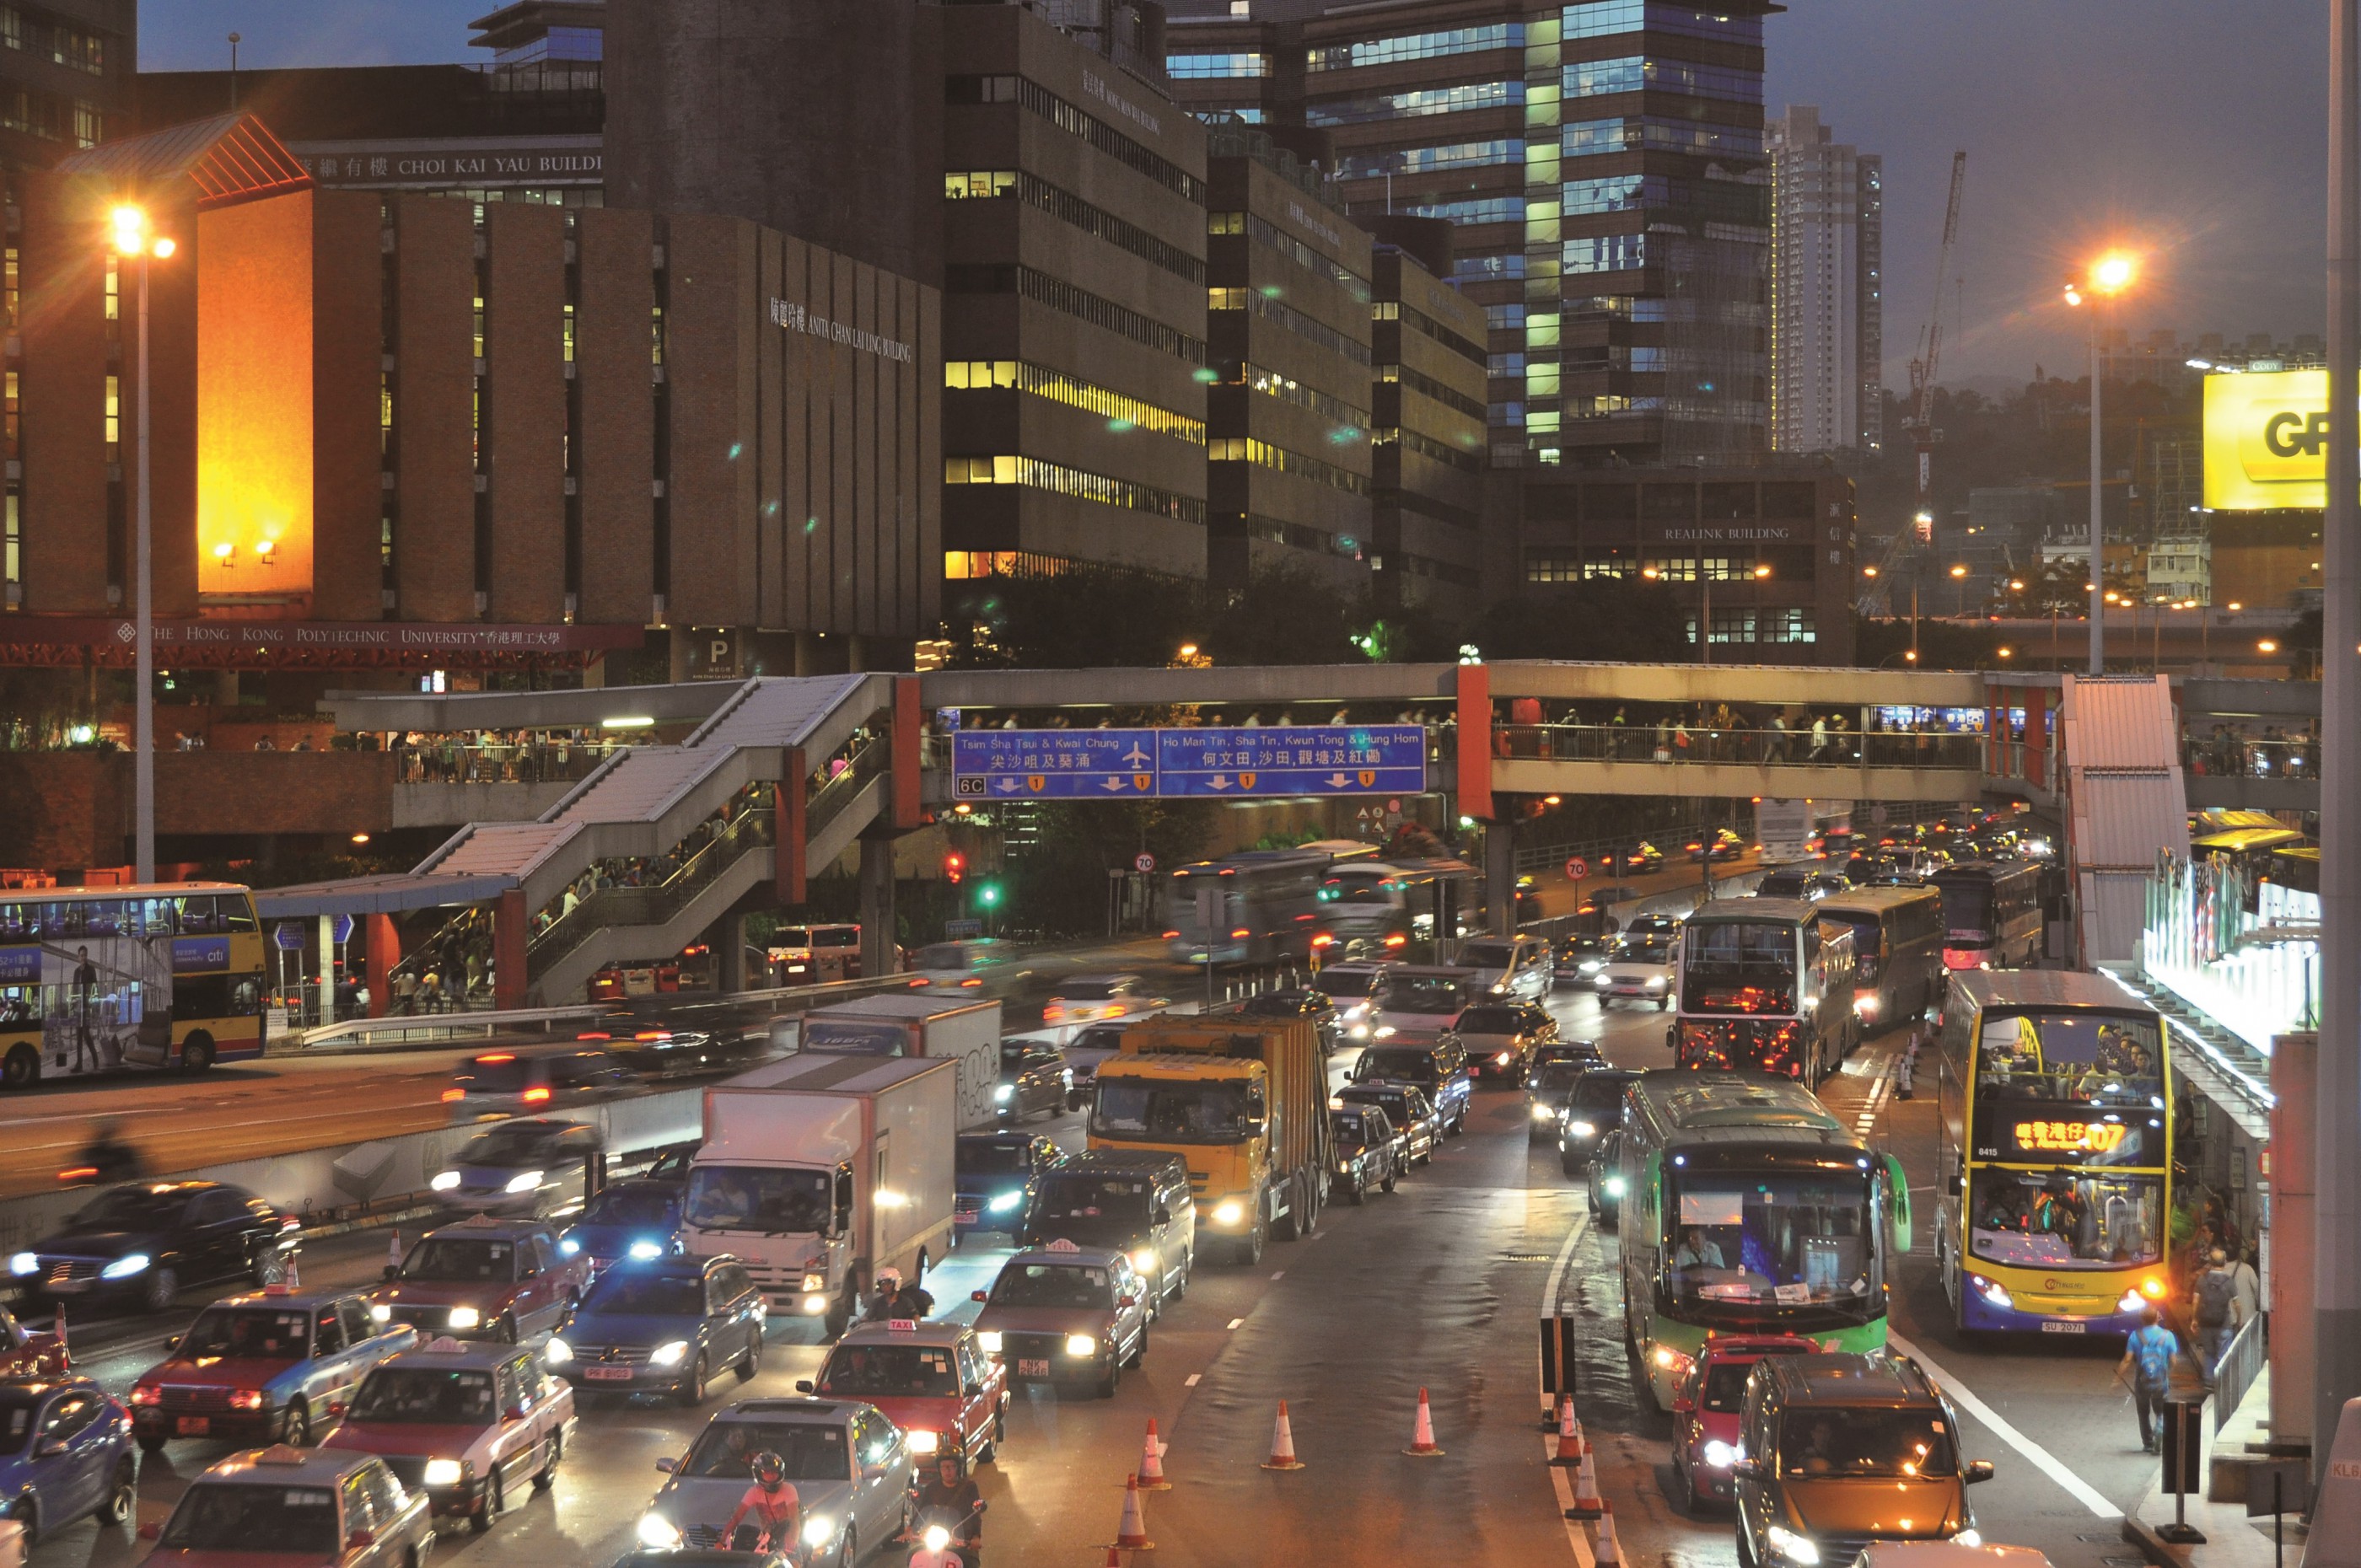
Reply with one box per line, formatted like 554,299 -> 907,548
368,1214 -> 590,1344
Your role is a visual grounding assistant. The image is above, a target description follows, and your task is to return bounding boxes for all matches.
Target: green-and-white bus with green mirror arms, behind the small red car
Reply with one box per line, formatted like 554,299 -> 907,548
1612,1067 -> 1910,1410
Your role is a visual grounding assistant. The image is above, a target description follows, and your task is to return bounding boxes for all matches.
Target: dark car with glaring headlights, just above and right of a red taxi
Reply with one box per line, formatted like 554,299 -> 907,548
975,1238 -> 1148,1400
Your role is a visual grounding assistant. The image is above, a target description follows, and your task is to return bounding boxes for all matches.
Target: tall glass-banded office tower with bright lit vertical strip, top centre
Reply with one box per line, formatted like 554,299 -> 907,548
1166,0 -> 1776,465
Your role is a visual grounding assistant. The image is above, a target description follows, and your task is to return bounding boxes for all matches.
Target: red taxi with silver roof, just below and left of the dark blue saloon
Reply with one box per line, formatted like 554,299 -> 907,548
321,1339 -> 573,1535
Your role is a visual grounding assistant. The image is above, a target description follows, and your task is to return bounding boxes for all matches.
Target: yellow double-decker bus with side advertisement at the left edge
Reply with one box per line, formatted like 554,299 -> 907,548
0,883 -> 262,1088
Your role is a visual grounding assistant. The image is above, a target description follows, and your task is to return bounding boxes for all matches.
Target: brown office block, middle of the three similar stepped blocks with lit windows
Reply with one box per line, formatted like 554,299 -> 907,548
1204,123 -> 1374,593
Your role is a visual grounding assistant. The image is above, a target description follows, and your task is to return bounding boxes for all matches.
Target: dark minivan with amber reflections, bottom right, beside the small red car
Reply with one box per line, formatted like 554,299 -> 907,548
1730,1356 -> 1993,1568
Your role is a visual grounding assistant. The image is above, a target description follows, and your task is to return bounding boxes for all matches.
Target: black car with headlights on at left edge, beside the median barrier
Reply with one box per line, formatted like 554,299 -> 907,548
7,1181 -> 300,1313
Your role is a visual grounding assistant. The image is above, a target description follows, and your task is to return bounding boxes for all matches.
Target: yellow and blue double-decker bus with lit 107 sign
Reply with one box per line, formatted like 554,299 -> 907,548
1936,968 -> 2172,1334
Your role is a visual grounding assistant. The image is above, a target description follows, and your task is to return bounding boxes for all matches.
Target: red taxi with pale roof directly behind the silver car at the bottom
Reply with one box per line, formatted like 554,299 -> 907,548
796,1318 -> 1008,1469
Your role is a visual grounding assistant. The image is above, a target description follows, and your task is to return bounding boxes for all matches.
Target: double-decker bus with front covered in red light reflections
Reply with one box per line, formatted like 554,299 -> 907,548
1670,897 -> 1858,1084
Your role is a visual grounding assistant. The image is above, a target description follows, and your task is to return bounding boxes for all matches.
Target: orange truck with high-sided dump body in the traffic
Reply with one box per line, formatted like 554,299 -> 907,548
1091,1016 -> 1331,1264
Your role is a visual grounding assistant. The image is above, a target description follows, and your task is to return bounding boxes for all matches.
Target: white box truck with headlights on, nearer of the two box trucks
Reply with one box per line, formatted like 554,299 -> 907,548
682,1055 -> 959,1336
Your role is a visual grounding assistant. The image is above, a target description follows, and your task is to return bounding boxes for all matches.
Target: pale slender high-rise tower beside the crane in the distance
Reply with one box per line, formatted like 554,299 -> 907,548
1766,104 -> 1884,451
